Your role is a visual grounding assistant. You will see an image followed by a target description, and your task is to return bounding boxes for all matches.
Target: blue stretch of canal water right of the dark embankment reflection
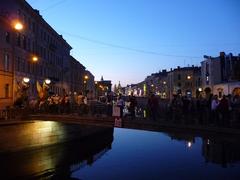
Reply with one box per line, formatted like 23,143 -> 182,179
71,128 -> 240,180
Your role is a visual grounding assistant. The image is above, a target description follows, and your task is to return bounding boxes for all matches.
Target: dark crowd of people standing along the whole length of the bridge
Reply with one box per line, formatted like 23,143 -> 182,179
19,88 -> 240,126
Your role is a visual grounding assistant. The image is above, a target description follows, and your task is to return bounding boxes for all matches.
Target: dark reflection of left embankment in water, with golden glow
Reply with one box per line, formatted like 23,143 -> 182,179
0,128 -> 113,179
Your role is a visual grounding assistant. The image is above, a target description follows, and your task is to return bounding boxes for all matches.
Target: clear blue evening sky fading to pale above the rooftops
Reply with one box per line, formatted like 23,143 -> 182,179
27,0 -> 240,85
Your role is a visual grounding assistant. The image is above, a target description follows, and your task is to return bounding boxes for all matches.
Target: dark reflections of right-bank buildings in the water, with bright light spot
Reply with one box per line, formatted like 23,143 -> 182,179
168,133 -> 240,167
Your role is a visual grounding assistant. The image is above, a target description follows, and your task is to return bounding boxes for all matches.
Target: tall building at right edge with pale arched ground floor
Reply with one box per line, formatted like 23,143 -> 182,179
201,52 -> 240,97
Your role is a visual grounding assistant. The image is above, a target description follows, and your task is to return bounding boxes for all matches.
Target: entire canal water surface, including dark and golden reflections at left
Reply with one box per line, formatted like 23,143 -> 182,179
0,121 -> 240,180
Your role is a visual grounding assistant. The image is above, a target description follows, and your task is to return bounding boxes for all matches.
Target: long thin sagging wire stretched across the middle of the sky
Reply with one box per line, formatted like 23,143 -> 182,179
60,31 -> 201,58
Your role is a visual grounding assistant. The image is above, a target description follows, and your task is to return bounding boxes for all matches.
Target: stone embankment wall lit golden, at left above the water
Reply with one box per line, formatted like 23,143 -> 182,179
0,121 -> 109,153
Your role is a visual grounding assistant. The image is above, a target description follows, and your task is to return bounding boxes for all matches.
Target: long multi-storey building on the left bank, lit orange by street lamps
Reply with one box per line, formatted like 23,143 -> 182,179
0,0 -> 94,108
